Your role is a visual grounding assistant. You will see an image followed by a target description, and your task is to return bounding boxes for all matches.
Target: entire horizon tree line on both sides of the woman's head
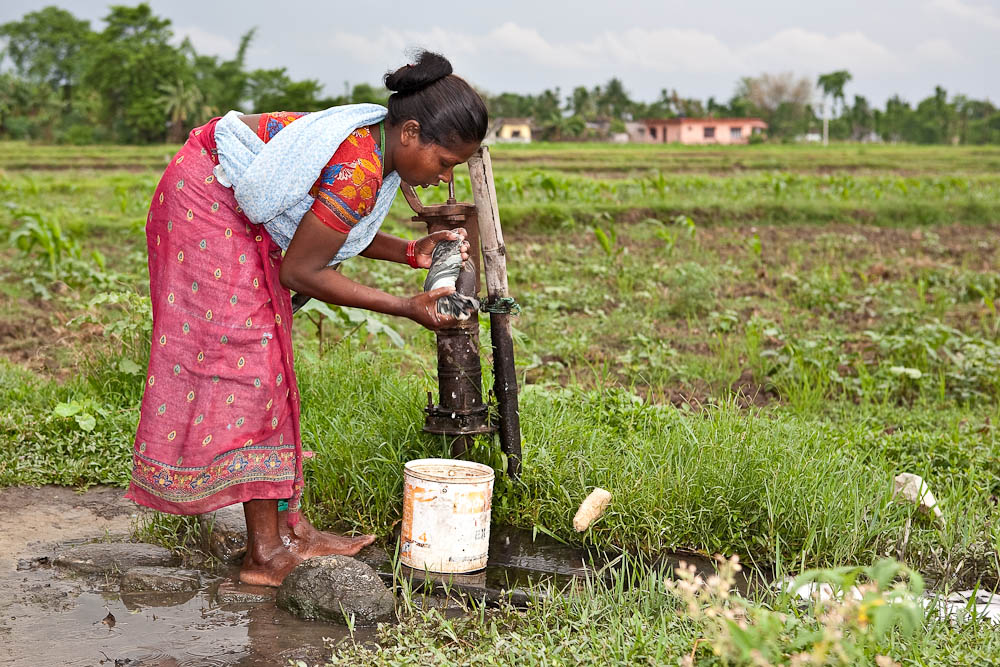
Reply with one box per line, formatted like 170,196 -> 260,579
0,3 -> 1000,144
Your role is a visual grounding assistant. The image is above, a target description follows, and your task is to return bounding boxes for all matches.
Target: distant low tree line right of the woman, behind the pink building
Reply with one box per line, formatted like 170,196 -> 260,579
487,70 -> 1000,144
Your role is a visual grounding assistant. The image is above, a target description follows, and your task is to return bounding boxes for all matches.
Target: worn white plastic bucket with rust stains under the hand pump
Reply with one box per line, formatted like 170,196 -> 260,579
399,459 -> 494,573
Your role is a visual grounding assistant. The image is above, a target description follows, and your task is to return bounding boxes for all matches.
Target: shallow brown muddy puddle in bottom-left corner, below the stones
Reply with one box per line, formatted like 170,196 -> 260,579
0,590 -> 360,667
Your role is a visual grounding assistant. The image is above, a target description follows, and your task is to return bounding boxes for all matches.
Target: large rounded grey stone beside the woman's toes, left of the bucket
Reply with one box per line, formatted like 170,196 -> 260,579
277,556 -> 395,625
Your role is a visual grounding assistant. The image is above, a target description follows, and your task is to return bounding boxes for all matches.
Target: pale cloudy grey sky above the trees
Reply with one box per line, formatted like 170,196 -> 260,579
0,0 -> 1000,106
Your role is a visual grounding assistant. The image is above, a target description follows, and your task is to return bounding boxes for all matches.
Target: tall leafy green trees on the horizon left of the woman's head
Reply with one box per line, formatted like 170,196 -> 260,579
0,3 -> 387,144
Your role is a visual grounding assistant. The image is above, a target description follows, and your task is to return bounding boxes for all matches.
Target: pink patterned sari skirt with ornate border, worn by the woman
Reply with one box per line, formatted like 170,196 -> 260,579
126,119 -> 302,525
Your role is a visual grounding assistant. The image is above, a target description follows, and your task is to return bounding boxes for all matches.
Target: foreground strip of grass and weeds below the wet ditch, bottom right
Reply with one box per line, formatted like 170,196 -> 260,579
318,567 -> 1000,666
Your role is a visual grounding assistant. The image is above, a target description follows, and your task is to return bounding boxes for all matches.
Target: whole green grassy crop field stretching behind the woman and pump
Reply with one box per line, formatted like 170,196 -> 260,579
0,143 -> 1000,664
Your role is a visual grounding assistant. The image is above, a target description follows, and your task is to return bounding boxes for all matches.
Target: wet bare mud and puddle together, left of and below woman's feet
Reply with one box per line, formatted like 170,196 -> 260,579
0,487 -> 366,667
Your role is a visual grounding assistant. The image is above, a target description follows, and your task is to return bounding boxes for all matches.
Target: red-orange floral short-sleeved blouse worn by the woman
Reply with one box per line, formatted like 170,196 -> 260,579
257,111 -> 382,234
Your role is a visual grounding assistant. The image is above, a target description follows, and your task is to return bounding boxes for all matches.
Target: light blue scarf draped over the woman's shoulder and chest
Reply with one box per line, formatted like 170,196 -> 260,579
215,104 -> 400,264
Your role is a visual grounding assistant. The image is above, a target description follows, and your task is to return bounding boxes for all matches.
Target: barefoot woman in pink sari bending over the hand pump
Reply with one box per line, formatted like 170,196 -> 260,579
127,52 -> 487,586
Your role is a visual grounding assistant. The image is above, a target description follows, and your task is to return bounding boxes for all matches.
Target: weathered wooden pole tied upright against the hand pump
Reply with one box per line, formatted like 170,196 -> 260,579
469,146 -> 521,479
